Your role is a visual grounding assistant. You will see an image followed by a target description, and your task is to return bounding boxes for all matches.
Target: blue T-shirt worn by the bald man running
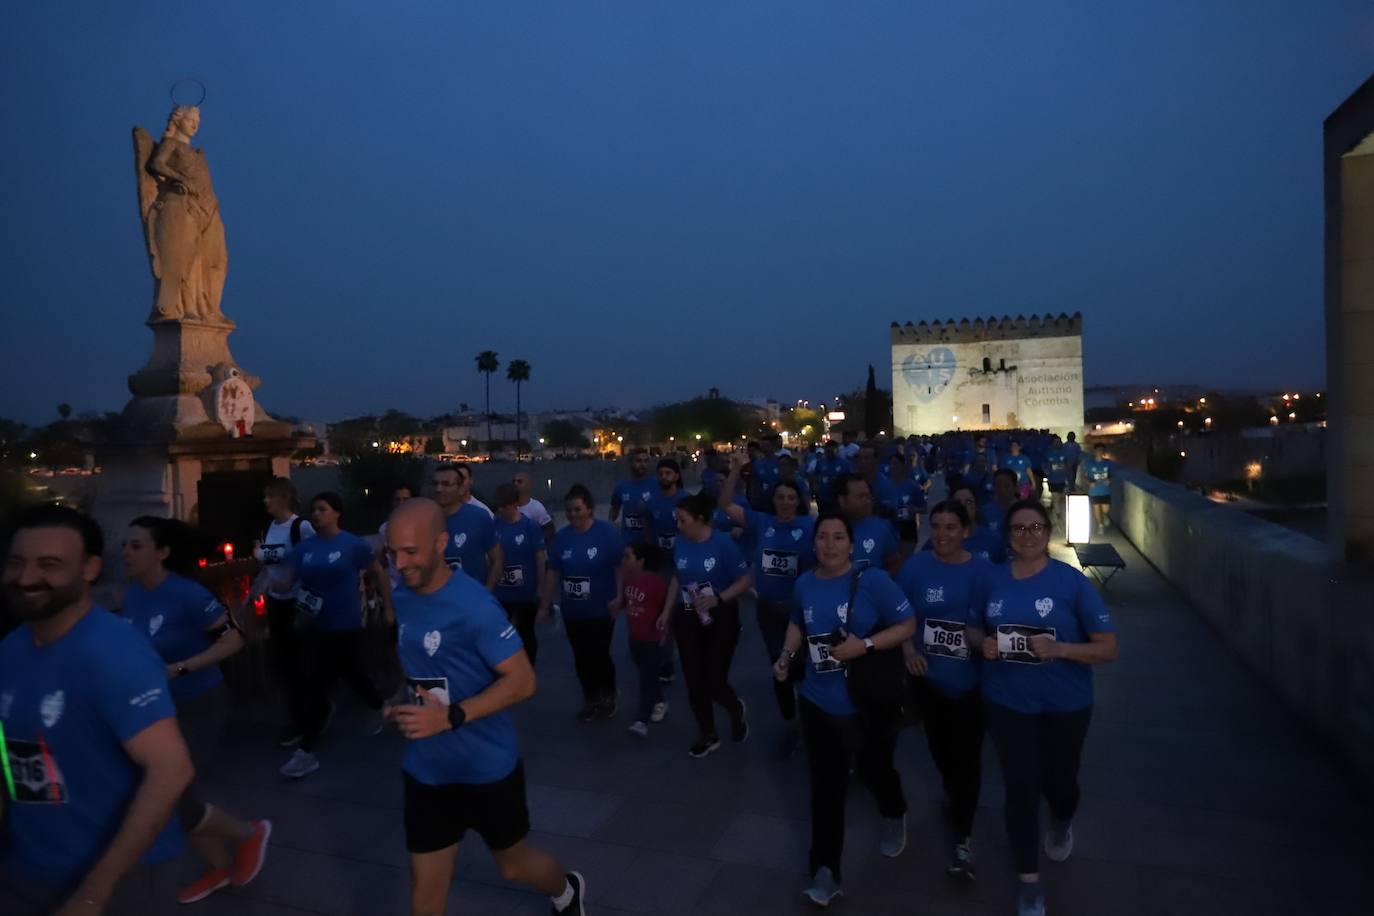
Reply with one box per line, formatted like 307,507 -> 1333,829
392,573 -> 525,786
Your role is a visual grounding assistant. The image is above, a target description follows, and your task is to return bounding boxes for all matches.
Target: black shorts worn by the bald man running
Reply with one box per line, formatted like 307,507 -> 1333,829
403,761 -> 529,854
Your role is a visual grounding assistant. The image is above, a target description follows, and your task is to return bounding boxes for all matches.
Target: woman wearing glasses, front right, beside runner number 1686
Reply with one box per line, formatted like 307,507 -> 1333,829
978,500 -> 1117,916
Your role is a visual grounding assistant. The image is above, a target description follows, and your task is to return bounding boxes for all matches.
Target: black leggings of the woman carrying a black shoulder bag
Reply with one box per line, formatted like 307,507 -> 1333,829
801,696 -> 907,882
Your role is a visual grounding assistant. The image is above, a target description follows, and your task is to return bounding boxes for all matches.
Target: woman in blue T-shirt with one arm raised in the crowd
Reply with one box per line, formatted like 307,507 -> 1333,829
717,453 -> 816,757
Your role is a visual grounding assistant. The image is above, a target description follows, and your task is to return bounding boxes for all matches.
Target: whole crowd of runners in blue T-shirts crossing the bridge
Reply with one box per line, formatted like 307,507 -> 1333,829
0,431 -> 1117,916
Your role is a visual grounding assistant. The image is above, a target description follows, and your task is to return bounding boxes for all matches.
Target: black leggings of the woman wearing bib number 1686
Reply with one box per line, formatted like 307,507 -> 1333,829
911,677 -> 982,843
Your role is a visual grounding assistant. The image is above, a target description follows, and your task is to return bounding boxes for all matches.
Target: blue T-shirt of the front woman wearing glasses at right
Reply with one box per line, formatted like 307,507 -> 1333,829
978,560 -> 1116,713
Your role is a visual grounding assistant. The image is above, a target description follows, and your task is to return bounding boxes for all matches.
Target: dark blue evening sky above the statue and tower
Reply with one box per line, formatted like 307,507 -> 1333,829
0,0 -> 1374,422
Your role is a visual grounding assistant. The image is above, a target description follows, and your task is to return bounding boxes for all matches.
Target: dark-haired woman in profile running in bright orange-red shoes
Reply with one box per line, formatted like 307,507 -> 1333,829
122,515 -> 272,904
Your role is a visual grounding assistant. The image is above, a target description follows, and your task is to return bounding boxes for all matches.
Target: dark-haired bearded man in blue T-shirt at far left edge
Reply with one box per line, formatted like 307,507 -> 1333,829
0,505 -> 192,916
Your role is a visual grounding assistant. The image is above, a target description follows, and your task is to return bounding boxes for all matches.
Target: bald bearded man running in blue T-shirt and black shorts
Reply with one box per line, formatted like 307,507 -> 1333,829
386,499 -> 587,916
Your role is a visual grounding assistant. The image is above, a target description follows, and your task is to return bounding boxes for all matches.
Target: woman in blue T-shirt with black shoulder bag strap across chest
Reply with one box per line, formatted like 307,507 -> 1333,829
774,515 -> 915,906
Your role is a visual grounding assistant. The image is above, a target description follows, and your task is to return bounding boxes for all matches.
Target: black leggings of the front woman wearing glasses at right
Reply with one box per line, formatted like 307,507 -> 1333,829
984,702 -> 1092,875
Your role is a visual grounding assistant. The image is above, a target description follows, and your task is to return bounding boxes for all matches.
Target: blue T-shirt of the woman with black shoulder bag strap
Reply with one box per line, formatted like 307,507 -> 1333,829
791,570 -> 911,715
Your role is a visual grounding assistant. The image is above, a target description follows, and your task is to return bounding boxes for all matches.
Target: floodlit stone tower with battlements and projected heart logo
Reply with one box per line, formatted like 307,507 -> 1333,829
892,312 -> 1083,435
